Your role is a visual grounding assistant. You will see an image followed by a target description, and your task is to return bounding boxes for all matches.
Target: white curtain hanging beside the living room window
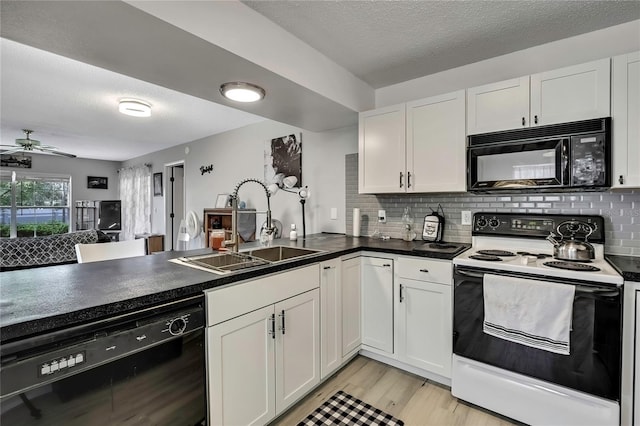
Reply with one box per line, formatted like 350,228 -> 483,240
120,165 -> 151,240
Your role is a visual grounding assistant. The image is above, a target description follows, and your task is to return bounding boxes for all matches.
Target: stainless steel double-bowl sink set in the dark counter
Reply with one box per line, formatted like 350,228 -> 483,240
170,246 -> 321,274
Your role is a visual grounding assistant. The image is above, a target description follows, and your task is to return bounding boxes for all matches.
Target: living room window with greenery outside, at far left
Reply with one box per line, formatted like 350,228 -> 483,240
0,171 -> 71,238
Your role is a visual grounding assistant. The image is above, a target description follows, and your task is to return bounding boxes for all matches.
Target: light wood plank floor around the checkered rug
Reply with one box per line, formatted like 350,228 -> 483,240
272,356 -> 518,426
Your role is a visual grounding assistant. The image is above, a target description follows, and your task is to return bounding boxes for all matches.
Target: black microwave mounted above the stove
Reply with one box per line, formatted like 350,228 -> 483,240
467,117 -> 611,192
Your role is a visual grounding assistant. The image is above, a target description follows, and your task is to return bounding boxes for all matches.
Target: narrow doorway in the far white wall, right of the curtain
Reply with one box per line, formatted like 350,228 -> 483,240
165,160 -> 185,250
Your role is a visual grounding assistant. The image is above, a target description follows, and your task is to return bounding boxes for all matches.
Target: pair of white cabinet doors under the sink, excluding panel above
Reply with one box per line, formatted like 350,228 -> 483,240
208,289 -> 320,425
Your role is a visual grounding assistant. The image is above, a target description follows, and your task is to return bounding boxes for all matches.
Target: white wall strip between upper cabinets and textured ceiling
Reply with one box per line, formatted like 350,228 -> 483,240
376,20 -> 640,108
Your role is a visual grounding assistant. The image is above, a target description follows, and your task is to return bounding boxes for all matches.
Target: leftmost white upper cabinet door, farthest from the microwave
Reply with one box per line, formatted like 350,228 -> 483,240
358,104 -> 406,194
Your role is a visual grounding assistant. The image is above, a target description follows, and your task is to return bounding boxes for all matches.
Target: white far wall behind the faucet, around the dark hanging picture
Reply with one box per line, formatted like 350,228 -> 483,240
124,120 -> 358,244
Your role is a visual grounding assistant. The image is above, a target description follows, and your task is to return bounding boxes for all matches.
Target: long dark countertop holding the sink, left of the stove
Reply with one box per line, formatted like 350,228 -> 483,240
0,234 -> 468,343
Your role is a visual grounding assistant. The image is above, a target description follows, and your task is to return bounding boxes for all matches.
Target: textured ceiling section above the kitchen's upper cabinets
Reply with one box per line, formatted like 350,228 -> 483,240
243,0 -> 640,88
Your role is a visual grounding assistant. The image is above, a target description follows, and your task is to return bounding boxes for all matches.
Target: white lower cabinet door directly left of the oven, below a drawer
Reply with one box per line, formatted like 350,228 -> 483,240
396,279 -> 453,378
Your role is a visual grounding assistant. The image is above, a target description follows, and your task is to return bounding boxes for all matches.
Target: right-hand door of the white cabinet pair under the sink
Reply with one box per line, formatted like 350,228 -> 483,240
276,289 -> 320,412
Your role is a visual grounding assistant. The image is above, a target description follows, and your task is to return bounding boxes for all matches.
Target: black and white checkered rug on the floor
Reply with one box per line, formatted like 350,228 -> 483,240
298,391 -> 404,426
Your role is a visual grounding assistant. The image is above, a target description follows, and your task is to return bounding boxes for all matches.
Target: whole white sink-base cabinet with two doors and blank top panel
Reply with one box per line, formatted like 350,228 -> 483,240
205,264 -> 320,425
